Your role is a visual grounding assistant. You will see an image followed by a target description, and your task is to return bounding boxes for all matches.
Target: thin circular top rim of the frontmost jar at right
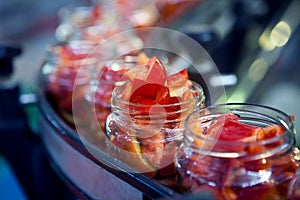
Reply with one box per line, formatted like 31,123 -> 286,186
184,103 -> 295,157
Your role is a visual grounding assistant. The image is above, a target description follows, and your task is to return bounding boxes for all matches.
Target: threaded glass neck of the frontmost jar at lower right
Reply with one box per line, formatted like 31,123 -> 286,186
184,103 -> 295,160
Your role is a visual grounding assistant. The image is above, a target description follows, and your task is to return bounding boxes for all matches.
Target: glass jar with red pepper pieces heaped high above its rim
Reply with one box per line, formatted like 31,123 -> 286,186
106,57 -> 205,184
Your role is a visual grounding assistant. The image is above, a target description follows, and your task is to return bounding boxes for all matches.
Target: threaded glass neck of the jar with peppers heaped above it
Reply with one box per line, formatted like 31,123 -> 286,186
112,81 -> 205,128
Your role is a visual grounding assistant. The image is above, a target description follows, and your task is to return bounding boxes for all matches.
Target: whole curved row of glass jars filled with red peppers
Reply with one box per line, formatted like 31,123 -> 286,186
47,2 -> 300,199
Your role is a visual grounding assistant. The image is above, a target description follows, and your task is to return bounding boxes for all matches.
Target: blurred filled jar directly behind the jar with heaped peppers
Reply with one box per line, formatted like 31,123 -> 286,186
85,31 -> 148,131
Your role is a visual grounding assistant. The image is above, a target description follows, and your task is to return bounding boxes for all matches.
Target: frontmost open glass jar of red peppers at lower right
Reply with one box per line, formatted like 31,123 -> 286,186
176,103 -> 299,200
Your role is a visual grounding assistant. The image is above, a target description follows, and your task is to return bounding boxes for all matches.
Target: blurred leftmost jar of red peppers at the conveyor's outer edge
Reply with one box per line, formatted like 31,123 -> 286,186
46,41 -> 96,126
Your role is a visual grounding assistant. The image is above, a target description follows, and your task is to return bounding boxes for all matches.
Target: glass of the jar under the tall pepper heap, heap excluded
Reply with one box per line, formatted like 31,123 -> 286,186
106,75 -> 205,181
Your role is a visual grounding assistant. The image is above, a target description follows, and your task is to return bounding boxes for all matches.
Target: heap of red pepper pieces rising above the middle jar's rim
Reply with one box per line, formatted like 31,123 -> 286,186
125,57 -> 192,118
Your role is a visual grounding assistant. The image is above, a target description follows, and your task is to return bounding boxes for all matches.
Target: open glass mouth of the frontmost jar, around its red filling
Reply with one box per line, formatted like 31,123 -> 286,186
184,103 -> 295,157
